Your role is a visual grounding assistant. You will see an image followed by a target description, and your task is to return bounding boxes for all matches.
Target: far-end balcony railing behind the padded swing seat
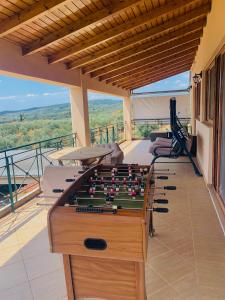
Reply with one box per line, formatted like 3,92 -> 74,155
132,118 -> 190,139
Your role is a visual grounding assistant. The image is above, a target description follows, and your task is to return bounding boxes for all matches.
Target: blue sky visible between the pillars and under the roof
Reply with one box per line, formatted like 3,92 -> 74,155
0,72 -> 189,111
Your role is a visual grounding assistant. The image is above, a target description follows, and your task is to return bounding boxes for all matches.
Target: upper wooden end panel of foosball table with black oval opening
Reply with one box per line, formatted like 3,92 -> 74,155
50,208 -> 144,261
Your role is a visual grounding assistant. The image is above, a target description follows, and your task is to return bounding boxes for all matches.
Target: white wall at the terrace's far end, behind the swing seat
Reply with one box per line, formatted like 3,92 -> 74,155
132,94 -> 191,119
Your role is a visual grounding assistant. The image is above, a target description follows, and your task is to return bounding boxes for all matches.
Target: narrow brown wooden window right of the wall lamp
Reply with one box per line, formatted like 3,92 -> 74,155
205,65 -> 216,121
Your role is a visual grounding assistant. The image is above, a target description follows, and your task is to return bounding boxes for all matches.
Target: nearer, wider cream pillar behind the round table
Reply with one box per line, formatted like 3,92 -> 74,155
70,86 -> 90,147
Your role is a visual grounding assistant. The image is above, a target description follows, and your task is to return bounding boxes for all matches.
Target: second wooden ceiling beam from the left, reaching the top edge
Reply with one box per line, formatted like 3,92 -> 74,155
23,0 -> 143,55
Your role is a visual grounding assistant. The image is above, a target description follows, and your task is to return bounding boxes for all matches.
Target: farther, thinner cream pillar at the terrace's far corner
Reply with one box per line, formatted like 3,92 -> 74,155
123,97 -> 132,141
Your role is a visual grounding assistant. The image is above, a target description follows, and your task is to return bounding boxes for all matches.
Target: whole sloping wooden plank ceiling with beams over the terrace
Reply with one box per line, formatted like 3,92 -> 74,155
0,0 -> 211,89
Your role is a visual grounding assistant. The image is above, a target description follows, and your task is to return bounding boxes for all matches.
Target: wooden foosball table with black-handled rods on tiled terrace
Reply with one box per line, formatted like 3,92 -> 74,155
48,165 -> 173,300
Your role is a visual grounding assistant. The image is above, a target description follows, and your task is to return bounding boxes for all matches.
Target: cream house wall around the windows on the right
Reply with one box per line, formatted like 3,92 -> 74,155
191,0 -> 225,184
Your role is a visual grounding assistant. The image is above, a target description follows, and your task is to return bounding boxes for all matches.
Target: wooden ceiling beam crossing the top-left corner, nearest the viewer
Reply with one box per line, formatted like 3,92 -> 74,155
0,0 -> 68,38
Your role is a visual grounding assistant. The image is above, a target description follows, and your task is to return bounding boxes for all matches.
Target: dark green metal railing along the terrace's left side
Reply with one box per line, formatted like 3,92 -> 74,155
0,123 -> 125,211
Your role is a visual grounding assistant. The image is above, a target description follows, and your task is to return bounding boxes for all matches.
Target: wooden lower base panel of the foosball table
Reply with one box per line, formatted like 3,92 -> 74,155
71,256 -> 145,300
